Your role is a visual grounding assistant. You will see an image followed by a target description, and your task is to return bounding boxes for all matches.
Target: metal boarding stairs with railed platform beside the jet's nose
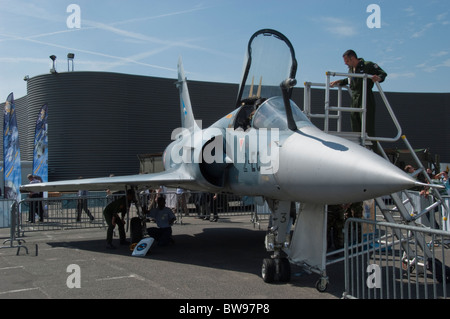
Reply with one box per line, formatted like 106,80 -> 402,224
304,72 -> 449,258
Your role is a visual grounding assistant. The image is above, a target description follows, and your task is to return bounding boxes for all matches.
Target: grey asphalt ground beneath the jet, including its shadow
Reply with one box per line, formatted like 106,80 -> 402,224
0,215 -> 344,304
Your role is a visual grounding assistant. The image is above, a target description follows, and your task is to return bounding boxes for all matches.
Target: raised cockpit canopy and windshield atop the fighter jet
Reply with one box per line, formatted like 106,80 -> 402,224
234,29 -> 312,130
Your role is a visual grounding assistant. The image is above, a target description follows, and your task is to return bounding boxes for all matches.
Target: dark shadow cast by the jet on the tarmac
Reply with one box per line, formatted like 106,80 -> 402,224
47,221 -> 344,298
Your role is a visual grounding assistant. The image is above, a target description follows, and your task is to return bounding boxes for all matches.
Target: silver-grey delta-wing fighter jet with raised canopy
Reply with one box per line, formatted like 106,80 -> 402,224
21,29 -> 417,288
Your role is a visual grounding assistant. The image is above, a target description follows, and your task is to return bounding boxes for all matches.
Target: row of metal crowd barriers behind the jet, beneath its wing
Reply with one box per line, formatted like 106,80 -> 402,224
0,192 -> 267,235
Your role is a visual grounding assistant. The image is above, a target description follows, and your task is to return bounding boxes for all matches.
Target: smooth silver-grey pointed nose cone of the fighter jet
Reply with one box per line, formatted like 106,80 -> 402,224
279,129 -> 415,204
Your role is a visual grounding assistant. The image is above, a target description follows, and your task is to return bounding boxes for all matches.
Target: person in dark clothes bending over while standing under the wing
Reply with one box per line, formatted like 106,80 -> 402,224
103,189 -> 134,249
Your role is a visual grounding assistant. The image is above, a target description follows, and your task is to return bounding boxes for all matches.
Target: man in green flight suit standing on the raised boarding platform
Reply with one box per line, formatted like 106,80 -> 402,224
330,50 -> 387,137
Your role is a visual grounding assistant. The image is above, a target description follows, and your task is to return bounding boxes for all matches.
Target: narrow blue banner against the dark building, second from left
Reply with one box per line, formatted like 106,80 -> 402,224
33,104 -> 48,182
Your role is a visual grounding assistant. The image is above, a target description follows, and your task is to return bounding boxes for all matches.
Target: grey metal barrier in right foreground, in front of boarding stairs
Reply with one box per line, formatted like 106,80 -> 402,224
343,218 -> 450,299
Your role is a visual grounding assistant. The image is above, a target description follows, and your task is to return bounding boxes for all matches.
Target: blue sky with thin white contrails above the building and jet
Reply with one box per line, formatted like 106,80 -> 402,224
0,0 -> 450,100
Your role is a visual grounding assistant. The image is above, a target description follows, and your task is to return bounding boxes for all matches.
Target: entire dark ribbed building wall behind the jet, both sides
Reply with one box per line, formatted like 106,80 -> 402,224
0,72 -> 450,181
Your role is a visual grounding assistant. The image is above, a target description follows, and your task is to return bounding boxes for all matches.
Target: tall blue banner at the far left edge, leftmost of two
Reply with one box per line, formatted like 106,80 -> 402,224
3,93 -> 22,201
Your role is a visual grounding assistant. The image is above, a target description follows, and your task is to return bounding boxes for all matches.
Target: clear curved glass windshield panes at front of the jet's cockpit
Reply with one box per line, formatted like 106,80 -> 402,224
252,96 -> 313,130
